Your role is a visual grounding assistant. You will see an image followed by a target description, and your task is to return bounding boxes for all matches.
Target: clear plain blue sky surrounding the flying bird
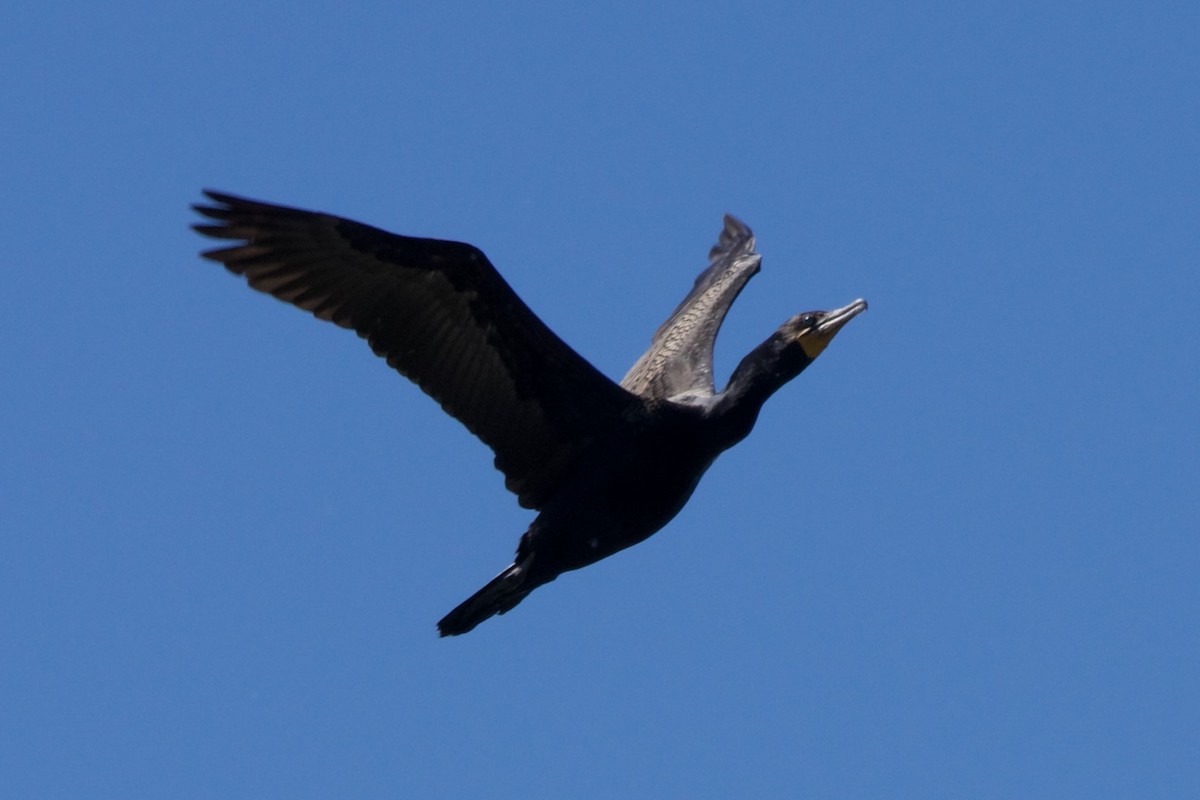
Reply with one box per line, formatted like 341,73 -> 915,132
0,1 -> 1200,799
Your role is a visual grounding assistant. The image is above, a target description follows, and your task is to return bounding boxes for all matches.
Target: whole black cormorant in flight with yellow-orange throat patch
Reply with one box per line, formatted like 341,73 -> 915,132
193,191 -> 866,636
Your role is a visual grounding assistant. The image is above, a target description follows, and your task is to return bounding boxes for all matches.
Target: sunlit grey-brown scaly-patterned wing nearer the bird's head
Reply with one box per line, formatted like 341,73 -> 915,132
620,215 -> 762,398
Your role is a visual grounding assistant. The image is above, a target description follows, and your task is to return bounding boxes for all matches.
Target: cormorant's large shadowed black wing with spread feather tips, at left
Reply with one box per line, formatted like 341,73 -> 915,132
193,192 -> 644,509
